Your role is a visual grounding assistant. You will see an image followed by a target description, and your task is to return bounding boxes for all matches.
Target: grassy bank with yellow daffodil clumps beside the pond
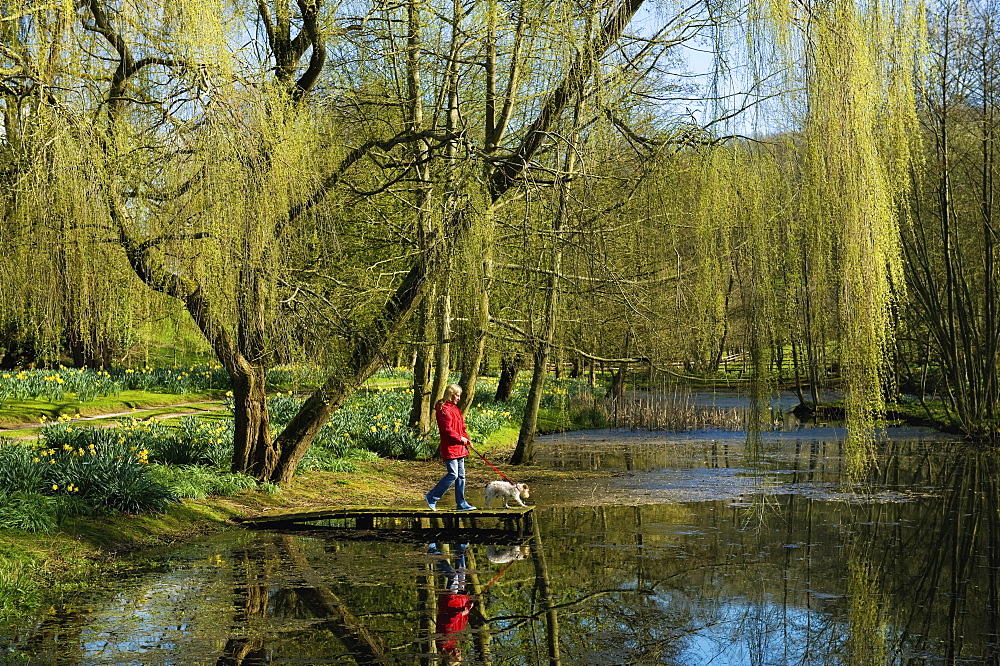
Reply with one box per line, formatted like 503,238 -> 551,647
0,368 -> 602,622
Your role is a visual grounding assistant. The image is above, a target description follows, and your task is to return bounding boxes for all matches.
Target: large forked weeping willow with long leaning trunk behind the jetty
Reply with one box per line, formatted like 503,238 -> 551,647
0,0 -> 680,482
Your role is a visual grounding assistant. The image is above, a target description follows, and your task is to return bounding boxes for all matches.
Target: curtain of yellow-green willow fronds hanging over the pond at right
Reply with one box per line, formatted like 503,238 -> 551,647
576,0 -> 925,471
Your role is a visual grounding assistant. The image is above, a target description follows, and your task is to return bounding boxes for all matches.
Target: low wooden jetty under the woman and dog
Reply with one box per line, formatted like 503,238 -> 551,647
237,506 -> 534,534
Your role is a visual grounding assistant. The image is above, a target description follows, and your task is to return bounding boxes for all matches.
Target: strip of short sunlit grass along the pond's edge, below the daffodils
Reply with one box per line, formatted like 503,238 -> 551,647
0,425 -> 608,623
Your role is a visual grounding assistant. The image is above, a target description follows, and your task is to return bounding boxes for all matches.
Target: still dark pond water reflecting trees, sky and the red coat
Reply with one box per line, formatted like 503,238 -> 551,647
0,428 -> 1000,666
